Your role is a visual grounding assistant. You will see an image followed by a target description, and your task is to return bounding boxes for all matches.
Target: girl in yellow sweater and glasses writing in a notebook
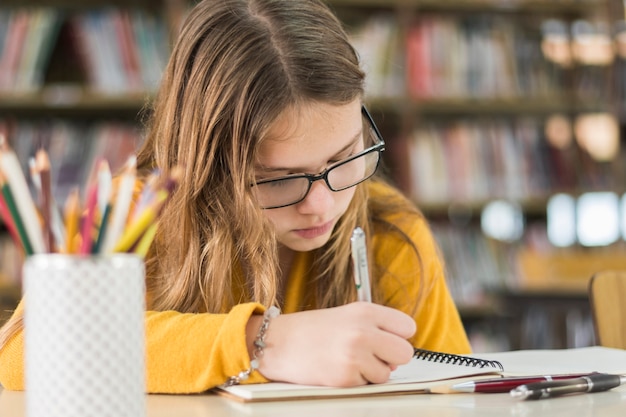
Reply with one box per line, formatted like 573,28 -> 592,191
0,0 -> 470,393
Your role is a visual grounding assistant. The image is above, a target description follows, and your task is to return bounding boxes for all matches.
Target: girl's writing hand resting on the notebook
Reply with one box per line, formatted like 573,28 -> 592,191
247,302 -> 415,387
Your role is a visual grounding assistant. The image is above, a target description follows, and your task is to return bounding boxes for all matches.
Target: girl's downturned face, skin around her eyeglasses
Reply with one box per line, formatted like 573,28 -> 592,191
255,100 -> 364,251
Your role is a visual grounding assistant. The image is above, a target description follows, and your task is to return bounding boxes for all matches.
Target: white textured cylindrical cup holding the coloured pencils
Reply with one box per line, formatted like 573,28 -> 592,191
23,254 -> 145,417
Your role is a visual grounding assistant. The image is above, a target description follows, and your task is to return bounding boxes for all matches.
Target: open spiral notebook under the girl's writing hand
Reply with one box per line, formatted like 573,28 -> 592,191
215,349 -> 504,402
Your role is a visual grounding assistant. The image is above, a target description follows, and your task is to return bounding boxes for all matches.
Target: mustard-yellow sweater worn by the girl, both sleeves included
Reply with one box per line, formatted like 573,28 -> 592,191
0,181 -> 470,393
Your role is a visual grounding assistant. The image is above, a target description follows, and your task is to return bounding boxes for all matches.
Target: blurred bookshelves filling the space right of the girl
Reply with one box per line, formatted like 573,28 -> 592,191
330,0 -> 626,349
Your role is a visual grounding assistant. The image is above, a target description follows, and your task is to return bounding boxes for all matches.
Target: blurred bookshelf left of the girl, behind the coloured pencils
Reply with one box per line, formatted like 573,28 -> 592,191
0,0 -> 189,323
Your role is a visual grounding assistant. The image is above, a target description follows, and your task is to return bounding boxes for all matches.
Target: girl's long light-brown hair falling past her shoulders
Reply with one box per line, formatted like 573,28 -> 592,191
138,0 -> 367,312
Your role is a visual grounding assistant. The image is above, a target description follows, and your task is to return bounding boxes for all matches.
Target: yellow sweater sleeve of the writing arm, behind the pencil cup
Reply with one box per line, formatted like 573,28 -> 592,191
0,303 -> 267,394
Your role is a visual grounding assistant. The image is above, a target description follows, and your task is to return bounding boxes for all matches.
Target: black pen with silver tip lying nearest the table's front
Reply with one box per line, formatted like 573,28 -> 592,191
511,372 -> 626,400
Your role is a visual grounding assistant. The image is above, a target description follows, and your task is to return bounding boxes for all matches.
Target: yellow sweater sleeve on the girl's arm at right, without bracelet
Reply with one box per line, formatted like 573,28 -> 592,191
373,210 -> 471,354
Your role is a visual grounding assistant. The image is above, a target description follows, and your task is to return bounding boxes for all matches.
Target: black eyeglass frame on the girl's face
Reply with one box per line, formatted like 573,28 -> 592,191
251,106 -> 385,210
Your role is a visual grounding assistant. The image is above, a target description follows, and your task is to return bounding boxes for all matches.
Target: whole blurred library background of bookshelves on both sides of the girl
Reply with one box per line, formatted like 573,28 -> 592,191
0,0 -> 626,352
